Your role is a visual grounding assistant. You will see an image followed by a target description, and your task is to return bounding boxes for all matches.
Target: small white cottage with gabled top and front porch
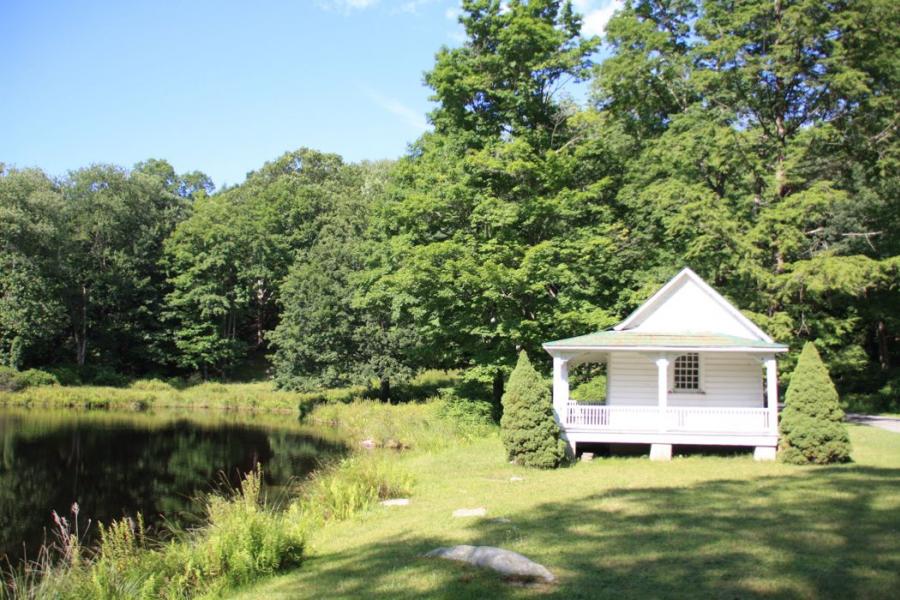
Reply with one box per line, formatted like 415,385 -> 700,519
544,269 -> 787,460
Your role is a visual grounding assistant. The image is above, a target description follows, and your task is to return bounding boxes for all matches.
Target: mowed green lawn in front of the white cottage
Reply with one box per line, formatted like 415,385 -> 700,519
232,426 -> 900,599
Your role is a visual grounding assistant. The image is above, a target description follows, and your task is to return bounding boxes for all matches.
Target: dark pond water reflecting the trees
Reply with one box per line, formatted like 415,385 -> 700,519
0,408 -> 343,564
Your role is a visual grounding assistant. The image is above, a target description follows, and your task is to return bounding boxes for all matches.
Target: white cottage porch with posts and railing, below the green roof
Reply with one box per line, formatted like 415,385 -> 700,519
548,336 -> 780,460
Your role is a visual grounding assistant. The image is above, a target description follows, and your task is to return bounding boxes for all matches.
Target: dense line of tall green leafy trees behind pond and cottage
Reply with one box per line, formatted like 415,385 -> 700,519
0,0 -> 900,408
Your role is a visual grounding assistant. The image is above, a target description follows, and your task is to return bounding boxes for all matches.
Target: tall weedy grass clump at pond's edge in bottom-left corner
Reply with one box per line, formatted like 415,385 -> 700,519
0,469 -> 305,600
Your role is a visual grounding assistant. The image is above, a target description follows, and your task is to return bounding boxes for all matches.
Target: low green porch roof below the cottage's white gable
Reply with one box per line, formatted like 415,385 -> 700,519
544,330 -> 787,351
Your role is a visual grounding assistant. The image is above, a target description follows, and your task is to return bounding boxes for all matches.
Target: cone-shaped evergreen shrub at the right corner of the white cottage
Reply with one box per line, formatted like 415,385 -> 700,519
779,342 -> 850,465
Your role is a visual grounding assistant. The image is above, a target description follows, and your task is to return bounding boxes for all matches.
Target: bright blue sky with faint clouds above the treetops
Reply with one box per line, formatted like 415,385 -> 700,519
0,0 -> 619,185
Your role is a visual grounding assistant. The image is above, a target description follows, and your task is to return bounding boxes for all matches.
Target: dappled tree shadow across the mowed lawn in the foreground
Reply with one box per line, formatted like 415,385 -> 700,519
253,466 -> 900,599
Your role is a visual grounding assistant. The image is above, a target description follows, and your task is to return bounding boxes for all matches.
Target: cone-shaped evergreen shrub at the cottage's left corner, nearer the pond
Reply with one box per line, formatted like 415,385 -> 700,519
500,351 -> 565,469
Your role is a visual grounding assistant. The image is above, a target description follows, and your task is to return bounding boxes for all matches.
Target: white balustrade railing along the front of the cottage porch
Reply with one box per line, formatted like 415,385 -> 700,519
563,402 -> 769,433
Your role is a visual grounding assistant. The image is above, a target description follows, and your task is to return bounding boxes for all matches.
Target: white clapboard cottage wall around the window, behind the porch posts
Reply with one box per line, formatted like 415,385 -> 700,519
607,352 -> 763,408
